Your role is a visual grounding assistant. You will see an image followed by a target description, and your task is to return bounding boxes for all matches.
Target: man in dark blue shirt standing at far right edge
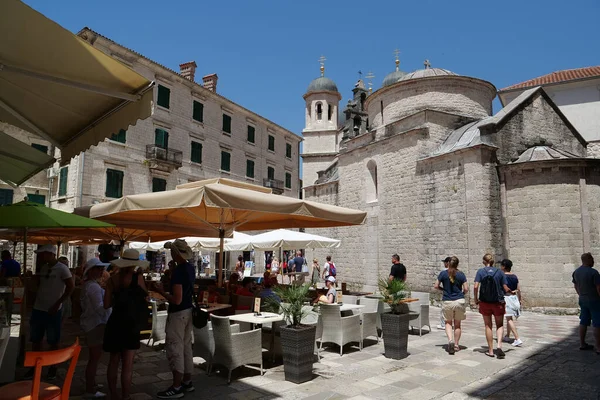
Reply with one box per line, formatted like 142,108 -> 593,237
573,253 -> 600,355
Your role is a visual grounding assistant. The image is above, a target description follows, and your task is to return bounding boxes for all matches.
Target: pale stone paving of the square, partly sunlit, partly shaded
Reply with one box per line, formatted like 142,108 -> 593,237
14,308 -> 600,400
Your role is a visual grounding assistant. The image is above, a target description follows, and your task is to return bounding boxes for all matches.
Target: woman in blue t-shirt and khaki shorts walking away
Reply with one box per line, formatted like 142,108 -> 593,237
435,257 -> 469,354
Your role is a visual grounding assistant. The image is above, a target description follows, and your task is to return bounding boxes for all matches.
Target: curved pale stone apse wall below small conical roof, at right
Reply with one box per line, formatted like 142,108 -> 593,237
505,165 -> 584,307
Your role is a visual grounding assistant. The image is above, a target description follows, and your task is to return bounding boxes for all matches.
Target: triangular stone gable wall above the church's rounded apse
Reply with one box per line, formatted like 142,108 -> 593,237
482,93 -> 586,164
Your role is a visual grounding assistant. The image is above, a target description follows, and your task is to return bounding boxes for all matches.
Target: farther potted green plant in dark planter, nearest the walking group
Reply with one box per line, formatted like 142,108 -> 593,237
378,278 -> 416,360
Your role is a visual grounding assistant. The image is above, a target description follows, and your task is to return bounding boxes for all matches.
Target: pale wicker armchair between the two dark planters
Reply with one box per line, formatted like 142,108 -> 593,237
319,304 -> 362,356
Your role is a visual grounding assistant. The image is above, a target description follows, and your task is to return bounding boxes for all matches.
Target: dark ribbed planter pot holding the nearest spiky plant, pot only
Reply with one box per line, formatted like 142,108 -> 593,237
280,326 -> 317,383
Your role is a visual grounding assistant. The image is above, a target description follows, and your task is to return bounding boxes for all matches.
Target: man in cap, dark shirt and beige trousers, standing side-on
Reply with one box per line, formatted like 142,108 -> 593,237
157,239 -> 195,399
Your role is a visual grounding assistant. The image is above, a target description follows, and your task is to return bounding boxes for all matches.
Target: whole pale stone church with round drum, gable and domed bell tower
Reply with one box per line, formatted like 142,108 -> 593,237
302,60 -> 600,308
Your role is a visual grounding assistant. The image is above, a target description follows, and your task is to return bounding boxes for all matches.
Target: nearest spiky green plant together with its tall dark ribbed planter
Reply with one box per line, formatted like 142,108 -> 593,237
267,284 -> 317,383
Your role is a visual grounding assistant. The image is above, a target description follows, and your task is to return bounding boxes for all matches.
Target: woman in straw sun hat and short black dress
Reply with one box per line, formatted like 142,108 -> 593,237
103,249 -> 149,400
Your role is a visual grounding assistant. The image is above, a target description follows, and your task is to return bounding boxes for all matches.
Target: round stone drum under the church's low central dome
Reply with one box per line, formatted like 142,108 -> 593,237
367,76 -> 495,130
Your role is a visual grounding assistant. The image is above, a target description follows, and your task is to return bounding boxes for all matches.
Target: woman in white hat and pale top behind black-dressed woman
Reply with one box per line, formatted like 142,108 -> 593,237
79,258 -> 111,398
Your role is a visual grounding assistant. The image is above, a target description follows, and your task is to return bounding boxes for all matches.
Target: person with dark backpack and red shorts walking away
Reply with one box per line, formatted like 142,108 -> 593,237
473,254 -> 511,359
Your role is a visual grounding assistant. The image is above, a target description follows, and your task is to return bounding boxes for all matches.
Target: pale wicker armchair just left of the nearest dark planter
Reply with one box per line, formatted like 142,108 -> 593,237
208,315 -> 263,383
